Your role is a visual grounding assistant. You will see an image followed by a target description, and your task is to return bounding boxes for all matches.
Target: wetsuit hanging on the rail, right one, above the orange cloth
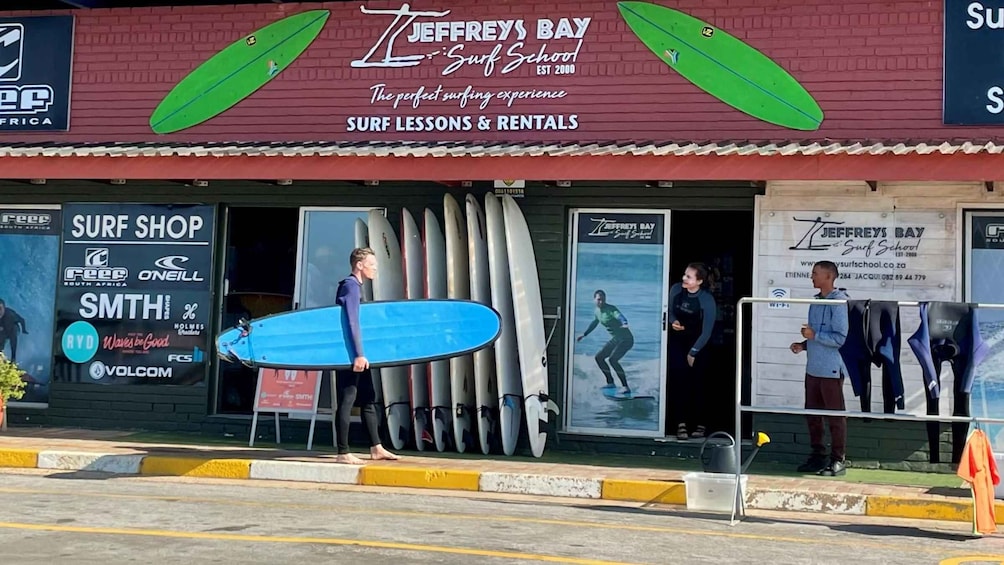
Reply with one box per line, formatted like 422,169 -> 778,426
907,302 -> 990,463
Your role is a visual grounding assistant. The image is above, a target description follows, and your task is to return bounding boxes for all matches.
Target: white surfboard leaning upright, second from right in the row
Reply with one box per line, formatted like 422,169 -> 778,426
485,193 -> 523,456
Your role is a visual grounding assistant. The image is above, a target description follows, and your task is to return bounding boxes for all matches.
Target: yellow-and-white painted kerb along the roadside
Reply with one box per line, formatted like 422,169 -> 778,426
0,428 -> 987,524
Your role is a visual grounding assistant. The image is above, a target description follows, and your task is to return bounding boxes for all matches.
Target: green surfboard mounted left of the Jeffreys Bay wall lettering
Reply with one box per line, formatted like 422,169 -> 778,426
150,10 -> 330,133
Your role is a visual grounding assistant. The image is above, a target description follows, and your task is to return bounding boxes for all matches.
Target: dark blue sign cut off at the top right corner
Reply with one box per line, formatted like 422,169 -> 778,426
944,0 -> 1004,124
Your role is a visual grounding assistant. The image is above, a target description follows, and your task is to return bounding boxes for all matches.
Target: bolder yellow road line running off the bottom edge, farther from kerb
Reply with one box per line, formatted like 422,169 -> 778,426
0,522 -> 632,565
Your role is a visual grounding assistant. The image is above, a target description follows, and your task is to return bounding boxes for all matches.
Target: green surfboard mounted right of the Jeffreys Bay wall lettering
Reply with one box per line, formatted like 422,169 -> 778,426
617,2 -> 822,130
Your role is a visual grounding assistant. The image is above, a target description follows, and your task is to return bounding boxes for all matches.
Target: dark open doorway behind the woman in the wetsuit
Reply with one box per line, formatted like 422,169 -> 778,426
666,211 -> 753,434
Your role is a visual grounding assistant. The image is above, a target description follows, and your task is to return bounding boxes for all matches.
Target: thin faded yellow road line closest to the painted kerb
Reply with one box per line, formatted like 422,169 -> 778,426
0,488 -> 944,555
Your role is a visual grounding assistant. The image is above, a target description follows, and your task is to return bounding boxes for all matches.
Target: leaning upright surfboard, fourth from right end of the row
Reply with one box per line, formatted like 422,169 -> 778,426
443,194 -> 477,453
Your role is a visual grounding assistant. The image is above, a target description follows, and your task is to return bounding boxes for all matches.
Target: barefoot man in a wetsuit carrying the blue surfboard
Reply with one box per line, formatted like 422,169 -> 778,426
334,247 -> 400,465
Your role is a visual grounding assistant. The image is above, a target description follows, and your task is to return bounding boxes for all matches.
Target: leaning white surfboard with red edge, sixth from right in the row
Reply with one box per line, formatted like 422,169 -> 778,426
401,208 -> 432,452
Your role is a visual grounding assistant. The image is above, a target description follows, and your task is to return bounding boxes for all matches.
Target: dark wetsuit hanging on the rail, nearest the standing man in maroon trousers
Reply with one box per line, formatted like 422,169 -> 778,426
840,300 -> 906,413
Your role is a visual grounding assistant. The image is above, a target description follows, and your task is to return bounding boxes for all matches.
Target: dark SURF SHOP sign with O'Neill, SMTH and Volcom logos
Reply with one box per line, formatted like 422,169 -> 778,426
54,204 -> 215,384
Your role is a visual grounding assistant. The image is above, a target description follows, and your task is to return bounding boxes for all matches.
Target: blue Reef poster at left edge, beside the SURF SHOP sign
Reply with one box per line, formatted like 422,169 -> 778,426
0,206 -> 62,405
